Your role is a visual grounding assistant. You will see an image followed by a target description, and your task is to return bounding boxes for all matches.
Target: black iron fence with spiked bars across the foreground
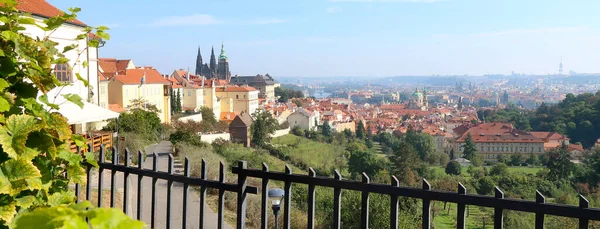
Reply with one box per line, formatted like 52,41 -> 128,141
75,147 -> 600,229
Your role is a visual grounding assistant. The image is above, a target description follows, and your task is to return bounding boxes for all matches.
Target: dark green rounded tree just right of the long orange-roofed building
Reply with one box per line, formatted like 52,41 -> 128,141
546,144 -> 573,181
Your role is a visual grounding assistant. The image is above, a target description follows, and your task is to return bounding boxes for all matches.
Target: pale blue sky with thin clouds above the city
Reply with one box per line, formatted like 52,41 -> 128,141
49,0 -> 600,77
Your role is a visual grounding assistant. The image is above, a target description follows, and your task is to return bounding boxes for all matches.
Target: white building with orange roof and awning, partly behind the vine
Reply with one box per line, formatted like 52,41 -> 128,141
17,0 -> 119,134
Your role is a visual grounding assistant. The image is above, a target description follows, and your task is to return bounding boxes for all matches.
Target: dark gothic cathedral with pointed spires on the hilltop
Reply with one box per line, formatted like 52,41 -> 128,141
196,44 -> 231,81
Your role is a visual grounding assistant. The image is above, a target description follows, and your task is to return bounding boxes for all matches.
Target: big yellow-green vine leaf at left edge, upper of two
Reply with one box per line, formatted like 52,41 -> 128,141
0,115 -> 40,158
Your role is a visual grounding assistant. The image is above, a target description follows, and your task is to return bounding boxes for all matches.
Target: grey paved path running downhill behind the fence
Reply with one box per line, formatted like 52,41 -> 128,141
92,141 -> 233,229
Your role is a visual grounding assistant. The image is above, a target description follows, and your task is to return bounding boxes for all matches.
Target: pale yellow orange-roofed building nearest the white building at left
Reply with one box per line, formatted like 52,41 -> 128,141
108,67 -> 171,123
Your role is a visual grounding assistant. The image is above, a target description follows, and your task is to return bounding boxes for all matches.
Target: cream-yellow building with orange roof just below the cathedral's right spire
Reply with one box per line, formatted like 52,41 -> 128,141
216,86 -> 259,114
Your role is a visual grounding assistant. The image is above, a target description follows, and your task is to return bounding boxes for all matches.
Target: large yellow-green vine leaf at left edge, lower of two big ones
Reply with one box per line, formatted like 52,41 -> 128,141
0,159 -> 43,196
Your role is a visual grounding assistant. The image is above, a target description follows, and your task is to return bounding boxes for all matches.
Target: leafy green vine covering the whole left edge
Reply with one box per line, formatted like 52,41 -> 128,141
0,0 -> 144,226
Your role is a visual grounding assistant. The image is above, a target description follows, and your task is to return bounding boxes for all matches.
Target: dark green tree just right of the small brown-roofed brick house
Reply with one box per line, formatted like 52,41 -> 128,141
250,109 -> 278,147
